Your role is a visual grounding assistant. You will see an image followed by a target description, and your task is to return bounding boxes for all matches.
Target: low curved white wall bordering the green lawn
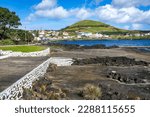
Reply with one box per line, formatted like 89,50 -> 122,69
0,48 -> 50,58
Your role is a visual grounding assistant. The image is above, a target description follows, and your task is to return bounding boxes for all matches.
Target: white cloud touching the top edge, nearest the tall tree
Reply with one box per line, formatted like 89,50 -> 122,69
27,0 -> 69,21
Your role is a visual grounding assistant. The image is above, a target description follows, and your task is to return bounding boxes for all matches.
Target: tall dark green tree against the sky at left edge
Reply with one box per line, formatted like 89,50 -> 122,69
0,7 -> 21,40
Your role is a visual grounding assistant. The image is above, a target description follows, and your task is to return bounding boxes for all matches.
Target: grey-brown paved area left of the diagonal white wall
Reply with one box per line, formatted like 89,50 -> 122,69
0,57 -> 49,92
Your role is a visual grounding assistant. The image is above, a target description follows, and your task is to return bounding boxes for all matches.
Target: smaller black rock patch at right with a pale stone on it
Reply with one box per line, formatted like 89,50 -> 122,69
104,66 -> 150,84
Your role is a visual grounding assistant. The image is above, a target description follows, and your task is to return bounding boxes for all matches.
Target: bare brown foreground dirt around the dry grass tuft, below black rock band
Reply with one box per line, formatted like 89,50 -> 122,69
47,65 -> 150,100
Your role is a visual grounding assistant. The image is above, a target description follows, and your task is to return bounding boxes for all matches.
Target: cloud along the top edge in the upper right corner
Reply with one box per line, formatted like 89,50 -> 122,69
112,0 -> 150,7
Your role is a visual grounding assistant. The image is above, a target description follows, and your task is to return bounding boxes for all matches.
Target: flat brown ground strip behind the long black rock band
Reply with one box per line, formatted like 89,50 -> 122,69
51,47 -> 150,62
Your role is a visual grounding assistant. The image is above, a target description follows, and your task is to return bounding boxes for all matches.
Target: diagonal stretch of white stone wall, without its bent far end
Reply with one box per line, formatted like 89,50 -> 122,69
0,59 -> 51,100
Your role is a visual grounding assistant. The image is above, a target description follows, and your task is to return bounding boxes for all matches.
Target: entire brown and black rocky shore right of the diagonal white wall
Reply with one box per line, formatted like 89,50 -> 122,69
23,47 -> 150,100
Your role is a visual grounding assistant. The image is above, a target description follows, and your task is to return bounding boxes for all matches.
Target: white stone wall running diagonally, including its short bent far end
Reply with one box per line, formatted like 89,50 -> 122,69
0,57 -> 73,100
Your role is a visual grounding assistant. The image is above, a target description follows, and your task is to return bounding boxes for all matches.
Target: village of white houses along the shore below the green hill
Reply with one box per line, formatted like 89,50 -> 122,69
30,30 -> 150,41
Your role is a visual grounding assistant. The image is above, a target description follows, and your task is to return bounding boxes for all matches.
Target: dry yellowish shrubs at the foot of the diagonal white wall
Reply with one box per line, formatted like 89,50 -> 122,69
23,77 -> 66,100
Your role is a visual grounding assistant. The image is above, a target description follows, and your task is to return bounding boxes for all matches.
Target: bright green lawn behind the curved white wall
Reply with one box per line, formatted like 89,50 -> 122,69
0,46 -> 46,52
